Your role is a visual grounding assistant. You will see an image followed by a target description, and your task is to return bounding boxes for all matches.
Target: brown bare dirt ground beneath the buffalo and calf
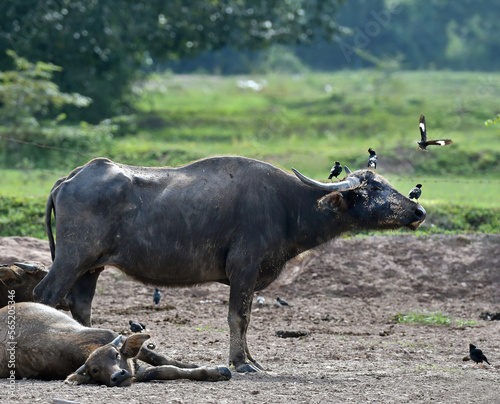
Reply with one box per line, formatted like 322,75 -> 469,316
0,235 -> 500,404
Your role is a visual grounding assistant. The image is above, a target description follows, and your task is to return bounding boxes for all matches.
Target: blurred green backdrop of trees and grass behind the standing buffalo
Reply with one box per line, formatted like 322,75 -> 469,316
0,0 -> 500,238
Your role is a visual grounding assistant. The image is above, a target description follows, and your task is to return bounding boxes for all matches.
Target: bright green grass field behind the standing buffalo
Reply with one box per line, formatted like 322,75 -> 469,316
0,70 -> 500,238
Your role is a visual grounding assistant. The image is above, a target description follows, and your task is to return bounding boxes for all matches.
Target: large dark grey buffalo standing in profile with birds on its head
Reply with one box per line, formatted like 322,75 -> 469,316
34,156 -> 425,372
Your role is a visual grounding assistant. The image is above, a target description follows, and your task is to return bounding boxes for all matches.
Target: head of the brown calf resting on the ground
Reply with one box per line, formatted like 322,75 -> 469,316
65,334 -> 150,387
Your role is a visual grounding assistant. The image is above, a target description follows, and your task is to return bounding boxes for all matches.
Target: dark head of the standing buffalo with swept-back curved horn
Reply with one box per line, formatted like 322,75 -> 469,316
293,167 -> 426,230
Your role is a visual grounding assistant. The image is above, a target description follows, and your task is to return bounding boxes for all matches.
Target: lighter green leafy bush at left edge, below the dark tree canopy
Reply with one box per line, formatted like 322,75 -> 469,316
0,51 -> 115,167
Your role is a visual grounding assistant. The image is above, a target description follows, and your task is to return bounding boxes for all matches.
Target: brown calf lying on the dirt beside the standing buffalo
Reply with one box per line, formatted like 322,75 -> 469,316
0,302 -> 231,386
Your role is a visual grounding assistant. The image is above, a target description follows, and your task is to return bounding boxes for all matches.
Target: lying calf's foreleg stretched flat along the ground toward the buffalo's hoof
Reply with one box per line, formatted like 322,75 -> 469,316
135,365 -> 231,382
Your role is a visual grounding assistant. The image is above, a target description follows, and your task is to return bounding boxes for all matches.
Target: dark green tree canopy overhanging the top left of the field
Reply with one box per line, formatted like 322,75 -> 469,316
0,0 -> 343,121
